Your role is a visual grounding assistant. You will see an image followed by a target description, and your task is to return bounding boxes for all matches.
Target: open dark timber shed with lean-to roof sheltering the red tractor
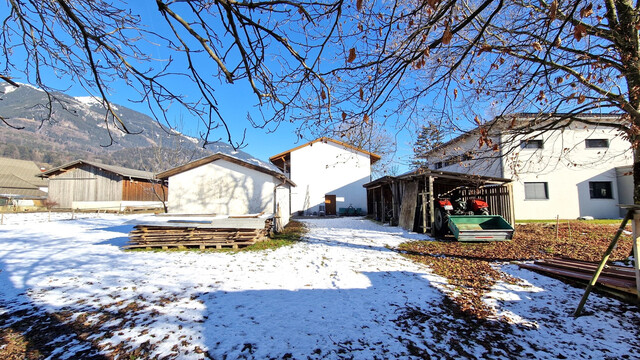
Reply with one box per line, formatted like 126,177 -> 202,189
364,169 -> 515,235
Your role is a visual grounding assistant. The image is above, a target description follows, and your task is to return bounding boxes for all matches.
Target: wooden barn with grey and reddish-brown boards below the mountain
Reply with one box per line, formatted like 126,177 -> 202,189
42,160 -> 168,211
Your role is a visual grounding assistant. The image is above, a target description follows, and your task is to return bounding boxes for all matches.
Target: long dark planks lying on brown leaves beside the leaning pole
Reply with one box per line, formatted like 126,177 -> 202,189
520,258 -> 636,297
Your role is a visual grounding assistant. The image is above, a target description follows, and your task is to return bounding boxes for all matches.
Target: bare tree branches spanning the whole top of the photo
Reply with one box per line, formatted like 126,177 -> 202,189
0,0 -> 640,200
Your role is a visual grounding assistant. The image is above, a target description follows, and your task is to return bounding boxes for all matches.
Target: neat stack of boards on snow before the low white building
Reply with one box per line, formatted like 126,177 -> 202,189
125,219 -> 273,249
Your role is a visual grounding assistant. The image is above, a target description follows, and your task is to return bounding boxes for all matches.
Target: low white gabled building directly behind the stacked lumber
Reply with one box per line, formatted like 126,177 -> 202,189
157,152 -> 295,225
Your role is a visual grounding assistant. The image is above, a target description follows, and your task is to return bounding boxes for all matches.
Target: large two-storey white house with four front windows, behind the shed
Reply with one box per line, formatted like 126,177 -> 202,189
427,114 -> 633,219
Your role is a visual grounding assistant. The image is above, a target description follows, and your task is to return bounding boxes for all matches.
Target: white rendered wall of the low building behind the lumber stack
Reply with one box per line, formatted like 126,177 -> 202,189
167,160 -> 288,215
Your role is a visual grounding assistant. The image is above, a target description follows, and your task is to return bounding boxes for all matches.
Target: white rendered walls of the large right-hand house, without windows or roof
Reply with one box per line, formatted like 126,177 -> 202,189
428,123 -> 633,219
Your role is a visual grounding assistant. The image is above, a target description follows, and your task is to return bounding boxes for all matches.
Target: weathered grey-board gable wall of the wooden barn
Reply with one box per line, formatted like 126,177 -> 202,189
49,164 -> 122,209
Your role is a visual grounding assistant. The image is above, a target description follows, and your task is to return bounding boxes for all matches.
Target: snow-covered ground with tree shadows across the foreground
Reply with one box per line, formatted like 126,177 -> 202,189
0,214 -> 640,359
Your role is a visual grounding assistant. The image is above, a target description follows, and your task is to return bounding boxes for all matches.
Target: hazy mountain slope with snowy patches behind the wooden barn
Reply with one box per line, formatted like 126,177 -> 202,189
0,83 -> 209,171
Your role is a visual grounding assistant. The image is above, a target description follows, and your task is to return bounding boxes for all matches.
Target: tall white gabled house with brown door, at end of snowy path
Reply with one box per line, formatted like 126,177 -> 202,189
269,137 -> 380,215
